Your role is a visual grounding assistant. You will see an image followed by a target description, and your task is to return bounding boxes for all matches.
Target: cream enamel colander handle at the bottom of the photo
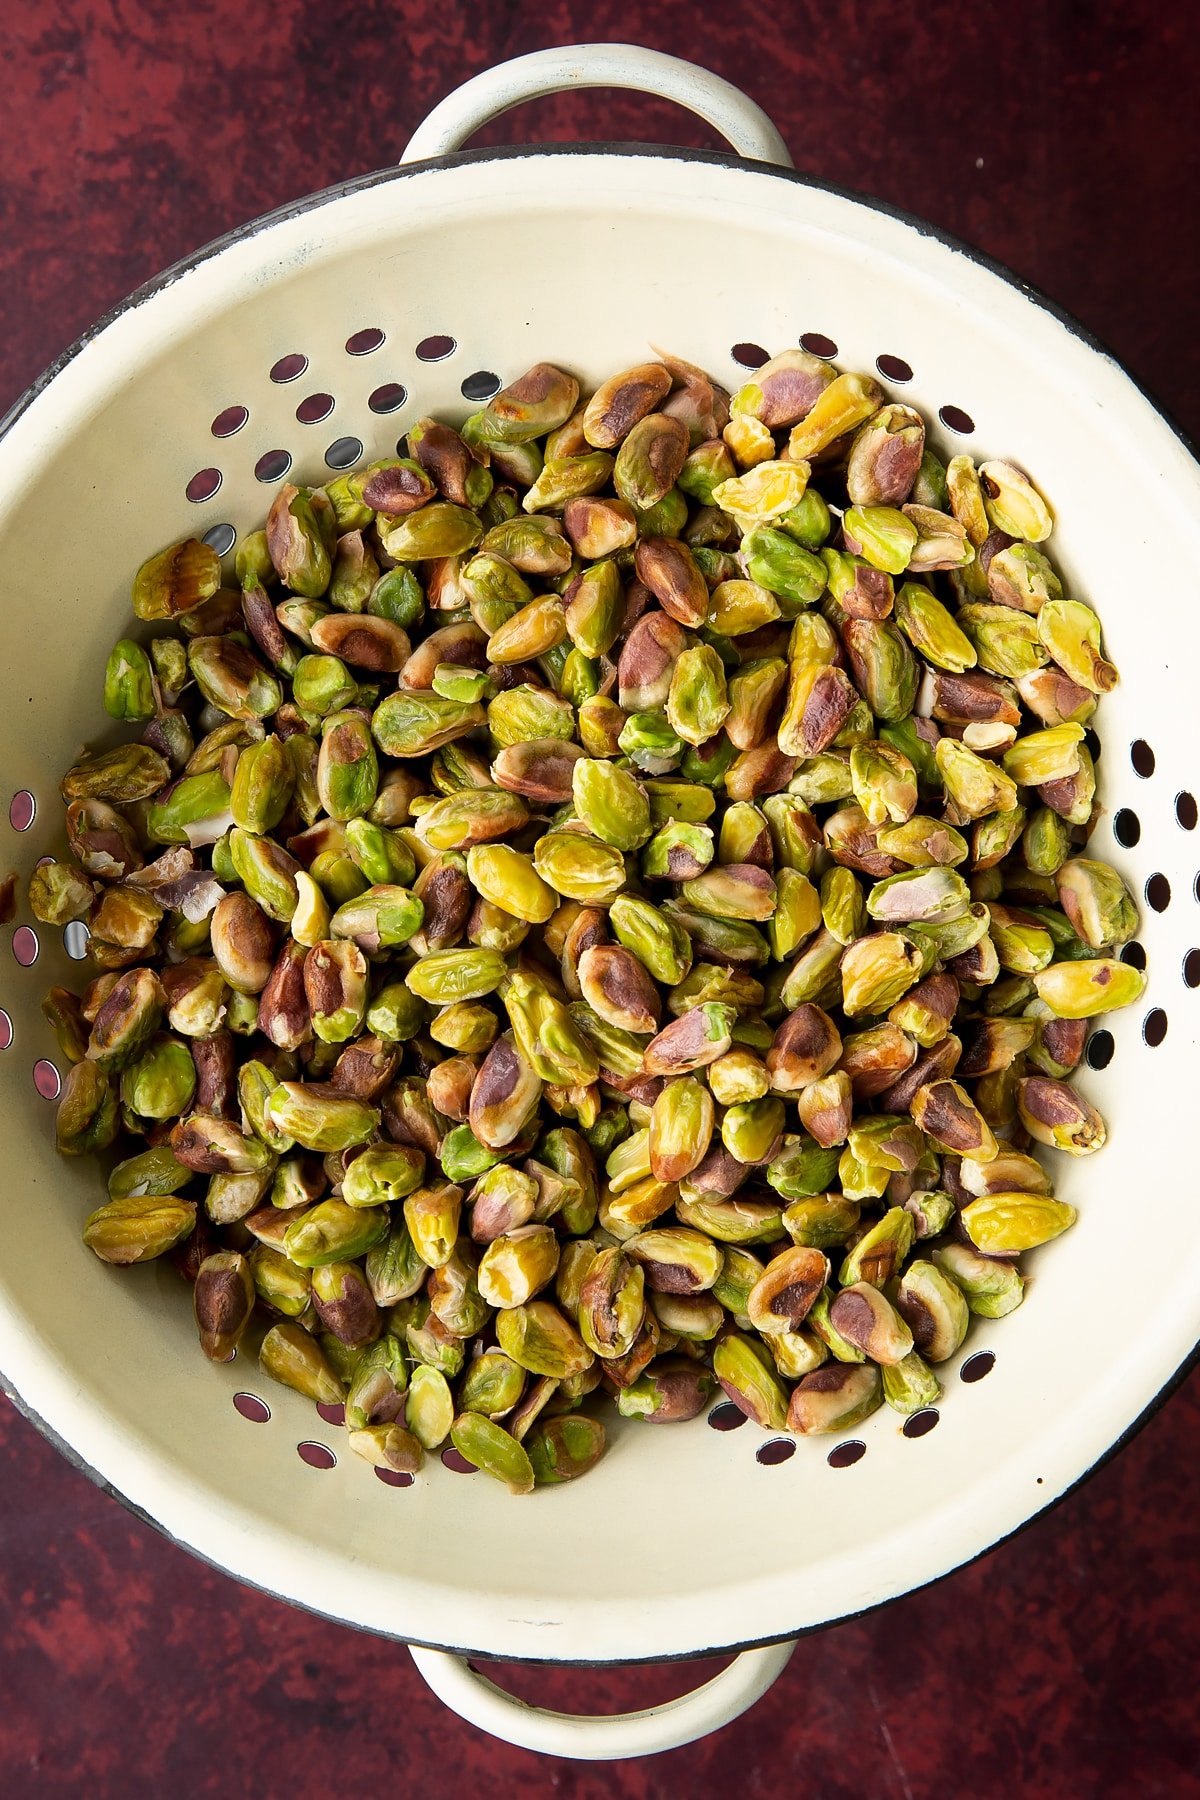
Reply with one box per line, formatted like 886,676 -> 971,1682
410,1642 -> 795,1762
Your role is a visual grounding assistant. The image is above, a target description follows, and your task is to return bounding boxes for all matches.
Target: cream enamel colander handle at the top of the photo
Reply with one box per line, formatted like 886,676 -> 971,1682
401,43 -> 792,169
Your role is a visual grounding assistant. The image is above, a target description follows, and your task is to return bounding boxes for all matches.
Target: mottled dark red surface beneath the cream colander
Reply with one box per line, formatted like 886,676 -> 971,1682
0,0 -> 1200,1800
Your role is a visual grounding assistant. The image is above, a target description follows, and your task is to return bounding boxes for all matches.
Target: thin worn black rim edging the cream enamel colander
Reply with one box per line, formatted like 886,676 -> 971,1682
0,144 -> 1200,1669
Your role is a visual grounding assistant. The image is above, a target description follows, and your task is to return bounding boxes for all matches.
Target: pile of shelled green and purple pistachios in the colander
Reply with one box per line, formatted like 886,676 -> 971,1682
29,349 -> 1144,1492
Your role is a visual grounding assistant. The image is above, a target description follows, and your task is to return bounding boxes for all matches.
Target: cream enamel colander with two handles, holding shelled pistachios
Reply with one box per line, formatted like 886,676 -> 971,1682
0,45 -> 1200,1757
